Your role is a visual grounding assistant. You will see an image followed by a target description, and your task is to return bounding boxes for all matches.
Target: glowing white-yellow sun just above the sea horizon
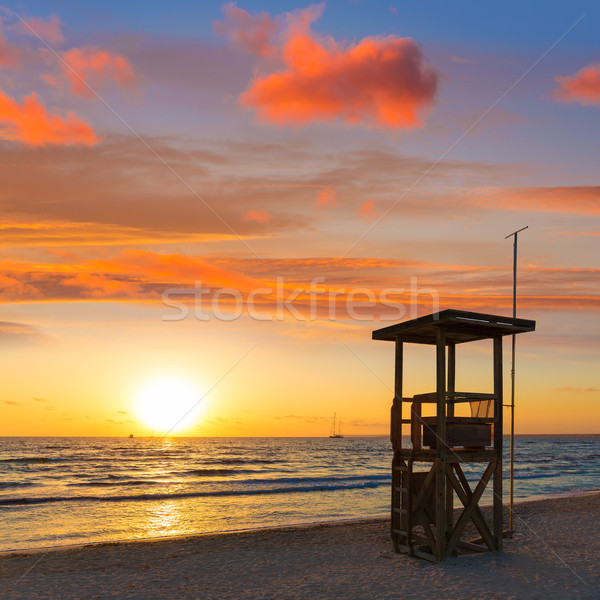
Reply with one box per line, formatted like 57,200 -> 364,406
136,377 -> 204,433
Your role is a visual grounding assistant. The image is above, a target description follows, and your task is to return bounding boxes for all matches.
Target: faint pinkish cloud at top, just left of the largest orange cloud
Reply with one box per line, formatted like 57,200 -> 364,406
214,2 -> 279,57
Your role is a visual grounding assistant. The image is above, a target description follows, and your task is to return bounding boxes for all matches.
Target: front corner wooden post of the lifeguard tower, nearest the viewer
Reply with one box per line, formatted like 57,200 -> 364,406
435,326 -> 447,560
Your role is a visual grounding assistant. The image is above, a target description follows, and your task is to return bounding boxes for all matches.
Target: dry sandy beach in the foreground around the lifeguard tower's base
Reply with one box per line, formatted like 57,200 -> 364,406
0,493 -> 600,600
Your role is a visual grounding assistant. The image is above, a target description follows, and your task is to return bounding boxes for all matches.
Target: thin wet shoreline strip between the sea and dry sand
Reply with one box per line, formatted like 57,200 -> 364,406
0,490 -> 600,559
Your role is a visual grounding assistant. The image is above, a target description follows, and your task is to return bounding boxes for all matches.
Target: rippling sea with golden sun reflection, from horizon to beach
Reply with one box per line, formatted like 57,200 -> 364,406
0,436 -> 600,552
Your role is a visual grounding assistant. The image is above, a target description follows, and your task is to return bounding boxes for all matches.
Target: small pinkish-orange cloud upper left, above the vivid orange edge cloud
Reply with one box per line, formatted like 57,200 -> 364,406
62,46 -> 135,98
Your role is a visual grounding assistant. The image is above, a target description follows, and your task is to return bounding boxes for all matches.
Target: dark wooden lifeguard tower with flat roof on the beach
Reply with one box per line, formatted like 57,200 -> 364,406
373,310 -> 535,561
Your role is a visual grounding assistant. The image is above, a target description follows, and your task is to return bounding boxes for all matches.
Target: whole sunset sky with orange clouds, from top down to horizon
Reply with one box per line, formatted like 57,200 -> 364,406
0,0 -> 600,436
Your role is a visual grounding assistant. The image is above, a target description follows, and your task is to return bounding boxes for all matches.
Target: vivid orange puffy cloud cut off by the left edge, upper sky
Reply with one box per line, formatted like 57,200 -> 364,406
0,92 -> 99,146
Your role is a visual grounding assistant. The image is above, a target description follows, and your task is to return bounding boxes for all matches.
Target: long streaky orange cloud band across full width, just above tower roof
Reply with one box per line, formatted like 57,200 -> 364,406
0,250 -> 600,319
